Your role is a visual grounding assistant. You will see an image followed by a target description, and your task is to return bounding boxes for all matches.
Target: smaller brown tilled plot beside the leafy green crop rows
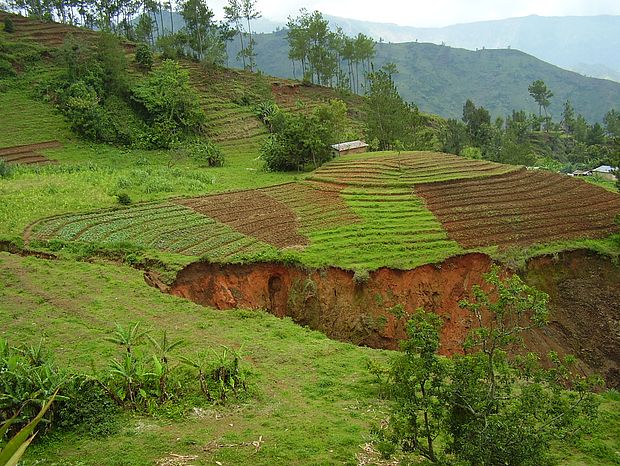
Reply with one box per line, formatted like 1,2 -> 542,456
174,190 -> 308,247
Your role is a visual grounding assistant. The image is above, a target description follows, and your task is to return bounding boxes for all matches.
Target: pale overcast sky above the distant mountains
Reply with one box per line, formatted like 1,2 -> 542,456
206,0 -> 620,27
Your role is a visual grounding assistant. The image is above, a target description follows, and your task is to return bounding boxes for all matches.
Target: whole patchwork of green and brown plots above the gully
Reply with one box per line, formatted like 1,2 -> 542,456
27,152 -> 620,270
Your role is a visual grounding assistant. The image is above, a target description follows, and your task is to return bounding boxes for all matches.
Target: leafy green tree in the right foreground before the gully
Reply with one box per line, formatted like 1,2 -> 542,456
378,267 -> 598,465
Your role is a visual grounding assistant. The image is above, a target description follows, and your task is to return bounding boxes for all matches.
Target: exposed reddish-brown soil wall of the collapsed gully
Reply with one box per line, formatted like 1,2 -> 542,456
162,250 -> 620,388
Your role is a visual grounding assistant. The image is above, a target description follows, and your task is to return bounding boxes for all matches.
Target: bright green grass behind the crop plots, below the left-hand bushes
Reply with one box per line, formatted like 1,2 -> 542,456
0,88 -> 299,244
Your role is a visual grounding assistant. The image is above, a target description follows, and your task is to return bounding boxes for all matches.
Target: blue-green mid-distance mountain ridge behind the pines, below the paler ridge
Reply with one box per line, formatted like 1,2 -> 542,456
229,31 -> 620,121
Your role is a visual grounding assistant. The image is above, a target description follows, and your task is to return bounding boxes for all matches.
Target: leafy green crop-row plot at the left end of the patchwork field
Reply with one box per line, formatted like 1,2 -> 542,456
29,203 -> 273,261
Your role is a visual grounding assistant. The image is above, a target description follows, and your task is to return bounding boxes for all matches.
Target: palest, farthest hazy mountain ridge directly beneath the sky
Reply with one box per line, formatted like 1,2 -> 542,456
248,15 -> 620,81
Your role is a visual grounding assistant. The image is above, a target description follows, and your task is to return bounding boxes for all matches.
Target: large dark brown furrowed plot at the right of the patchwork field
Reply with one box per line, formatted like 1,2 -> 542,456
415,169 -> 620,248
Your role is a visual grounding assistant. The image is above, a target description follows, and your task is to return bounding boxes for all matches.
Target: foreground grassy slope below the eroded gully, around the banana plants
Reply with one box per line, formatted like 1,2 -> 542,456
0,253 -> 620,466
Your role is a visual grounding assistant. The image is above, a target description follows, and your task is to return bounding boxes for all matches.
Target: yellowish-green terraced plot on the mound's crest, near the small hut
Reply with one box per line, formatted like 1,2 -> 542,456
309,152 -> 519,187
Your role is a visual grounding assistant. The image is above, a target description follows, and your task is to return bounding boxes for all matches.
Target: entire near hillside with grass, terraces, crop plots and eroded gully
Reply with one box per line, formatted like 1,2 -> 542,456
0,15 -> 620,466
